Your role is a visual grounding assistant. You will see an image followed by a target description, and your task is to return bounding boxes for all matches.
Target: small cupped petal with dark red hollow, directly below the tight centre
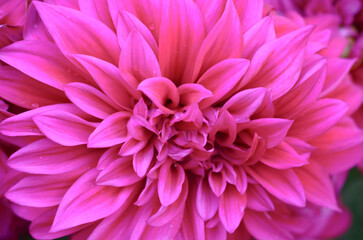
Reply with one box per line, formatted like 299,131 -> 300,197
158,160 -> 185,206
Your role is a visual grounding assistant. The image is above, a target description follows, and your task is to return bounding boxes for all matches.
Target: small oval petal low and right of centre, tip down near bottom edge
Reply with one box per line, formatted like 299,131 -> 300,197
219,184 -> 247,233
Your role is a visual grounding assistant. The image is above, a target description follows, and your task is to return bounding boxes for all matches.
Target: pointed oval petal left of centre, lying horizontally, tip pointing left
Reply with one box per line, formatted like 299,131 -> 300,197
33,111 -> 95,146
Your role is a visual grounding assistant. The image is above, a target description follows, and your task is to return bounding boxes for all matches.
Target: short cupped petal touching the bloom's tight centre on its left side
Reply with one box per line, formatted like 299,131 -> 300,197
88,112 -> 130,148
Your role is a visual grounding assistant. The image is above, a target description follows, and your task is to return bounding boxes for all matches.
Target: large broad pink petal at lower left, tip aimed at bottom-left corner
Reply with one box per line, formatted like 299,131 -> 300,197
51,170 -> 140,232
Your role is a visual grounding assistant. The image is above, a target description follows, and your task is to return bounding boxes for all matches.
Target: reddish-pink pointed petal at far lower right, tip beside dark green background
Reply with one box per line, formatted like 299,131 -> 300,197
295,161 -> 339,210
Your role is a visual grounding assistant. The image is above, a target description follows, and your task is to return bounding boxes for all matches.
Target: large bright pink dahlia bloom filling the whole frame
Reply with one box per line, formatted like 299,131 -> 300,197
0,0 -> 363,239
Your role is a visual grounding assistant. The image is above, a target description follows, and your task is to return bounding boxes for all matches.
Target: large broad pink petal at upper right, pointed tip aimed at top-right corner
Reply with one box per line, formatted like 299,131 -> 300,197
240,26 -> 312,100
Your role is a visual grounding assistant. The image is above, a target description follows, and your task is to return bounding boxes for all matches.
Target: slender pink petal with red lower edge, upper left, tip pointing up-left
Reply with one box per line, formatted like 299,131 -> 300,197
73,55 -> 138,109
